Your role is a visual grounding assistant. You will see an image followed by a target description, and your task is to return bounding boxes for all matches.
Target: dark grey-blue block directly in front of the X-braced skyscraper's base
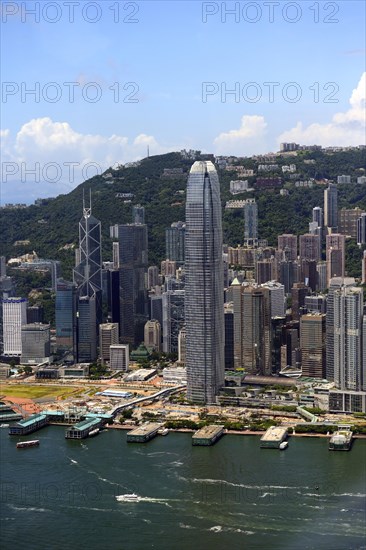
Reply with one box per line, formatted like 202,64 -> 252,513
76,294 -> 98,363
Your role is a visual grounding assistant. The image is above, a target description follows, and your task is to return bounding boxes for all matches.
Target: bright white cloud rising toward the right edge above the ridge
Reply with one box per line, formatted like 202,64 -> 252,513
277,72 -> 366,147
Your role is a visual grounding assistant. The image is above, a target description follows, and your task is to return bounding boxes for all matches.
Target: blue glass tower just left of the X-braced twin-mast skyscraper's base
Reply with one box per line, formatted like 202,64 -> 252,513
56,279 -> 76,350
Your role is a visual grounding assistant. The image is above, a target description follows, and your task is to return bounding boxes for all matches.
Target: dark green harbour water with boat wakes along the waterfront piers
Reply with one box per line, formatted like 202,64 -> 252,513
0,426 -> 366,550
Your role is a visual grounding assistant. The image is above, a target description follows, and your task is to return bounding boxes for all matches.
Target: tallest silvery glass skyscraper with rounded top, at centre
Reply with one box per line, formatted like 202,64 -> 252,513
185,161 -> 225,403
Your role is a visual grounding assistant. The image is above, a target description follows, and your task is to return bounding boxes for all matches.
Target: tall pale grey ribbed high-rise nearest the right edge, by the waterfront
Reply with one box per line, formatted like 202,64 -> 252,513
333,286 -> 363,391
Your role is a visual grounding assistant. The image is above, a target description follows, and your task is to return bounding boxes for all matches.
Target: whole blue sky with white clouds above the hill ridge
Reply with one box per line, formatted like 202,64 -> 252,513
1,0 -> 365,203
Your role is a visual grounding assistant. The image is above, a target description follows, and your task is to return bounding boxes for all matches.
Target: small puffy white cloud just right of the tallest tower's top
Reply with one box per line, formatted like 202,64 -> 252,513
214,115 -> 267,156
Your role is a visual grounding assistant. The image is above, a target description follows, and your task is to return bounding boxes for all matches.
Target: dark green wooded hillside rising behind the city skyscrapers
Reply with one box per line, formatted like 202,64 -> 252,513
0,149 -> 366,277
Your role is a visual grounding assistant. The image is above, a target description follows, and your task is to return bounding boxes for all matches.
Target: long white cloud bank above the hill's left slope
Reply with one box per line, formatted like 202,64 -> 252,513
1,117 -> 177,202
